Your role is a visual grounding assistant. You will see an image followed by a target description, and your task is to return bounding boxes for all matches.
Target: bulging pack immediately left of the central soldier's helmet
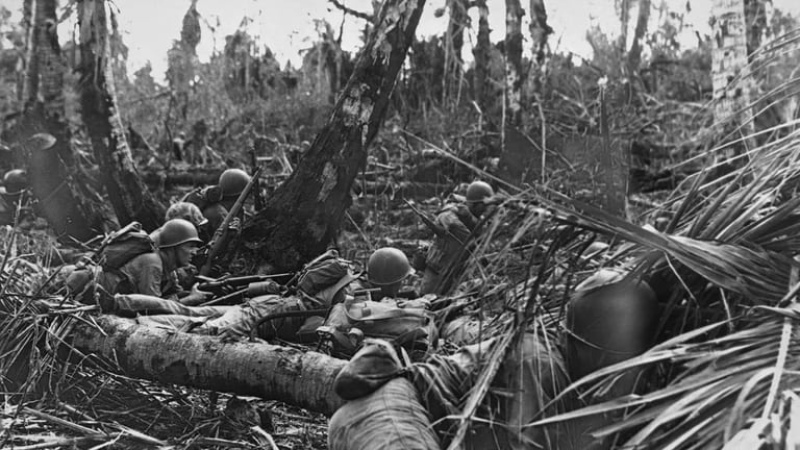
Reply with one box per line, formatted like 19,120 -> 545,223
297,249 -> 357,306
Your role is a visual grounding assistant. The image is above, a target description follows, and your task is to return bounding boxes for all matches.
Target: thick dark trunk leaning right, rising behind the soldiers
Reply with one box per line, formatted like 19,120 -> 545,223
236,0 -> 425,270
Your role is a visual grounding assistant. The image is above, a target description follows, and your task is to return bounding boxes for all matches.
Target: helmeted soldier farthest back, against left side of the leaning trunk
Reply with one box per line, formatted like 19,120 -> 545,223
182,169 -> 250,232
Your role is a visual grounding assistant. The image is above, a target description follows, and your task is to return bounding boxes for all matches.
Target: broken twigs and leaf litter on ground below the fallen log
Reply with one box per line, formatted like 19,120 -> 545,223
0,373 -> 327,450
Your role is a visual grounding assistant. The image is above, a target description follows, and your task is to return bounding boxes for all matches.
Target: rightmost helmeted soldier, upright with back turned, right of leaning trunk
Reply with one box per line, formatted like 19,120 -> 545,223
420,181 -> 494,295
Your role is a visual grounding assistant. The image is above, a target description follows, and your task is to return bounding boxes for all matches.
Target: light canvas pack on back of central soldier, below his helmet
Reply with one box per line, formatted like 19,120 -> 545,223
317,299 -> 437,355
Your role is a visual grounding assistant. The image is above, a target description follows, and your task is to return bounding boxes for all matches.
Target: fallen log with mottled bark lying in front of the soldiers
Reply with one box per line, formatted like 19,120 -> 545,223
71,316 -> 346,416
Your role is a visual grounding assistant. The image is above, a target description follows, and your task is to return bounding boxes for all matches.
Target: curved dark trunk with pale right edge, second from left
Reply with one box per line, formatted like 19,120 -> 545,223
78,0 -> 165,231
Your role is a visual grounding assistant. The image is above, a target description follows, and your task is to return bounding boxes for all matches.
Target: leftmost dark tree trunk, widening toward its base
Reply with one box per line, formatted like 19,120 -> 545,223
10,0 -> 102,241
